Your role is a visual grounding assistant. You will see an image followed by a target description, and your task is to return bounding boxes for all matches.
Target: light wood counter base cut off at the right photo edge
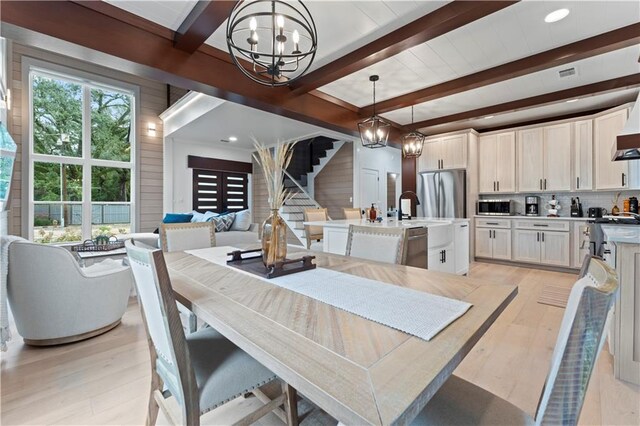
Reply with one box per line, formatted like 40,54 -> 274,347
602,225 -> 640,385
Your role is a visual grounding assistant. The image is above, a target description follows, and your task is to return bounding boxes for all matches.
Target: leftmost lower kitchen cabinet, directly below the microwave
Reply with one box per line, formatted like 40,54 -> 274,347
475,219 -> 511,260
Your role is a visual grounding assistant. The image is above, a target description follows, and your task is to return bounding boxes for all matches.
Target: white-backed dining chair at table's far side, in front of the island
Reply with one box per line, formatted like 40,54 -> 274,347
345,225 -> 409,265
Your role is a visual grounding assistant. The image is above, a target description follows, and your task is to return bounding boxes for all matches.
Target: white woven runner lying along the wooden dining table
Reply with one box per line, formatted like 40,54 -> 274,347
186,247 -> 472,340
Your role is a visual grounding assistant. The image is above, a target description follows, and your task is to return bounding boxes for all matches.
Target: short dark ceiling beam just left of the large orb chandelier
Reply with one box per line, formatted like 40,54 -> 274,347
174,0 -> 238,53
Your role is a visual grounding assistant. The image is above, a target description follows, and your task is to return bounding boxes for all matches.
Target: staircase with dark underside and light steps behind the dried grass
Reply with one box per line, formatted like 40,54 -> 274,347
280,137 -> 344,246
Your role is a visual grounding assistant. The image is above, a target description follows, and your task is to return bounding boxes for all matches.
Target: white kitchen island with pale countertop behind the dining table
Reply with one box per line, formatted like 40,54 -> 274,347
304,217 -> 469,275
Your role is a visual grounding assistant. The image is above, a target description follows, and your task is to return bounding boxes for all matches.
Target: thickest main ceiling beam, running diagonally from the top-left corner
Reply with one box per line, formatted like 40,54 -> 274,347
0,0 -> 402,146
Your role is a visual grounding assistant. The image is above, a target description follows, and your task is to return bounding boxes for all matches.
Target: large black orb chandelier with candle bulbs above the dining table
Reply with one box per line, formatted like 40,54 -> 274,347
227,0 -> 318,87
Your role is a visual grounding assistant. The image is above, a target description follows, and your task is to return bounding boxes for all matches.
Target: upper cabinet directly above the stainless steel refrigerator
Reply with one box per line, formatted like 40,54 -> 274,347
418,134 -> 468,172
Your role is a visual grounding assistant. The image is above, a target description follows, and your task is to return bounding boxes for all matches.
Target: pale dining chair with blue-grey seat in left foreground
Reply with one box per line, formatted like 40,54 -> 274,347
125,240 -> 297,426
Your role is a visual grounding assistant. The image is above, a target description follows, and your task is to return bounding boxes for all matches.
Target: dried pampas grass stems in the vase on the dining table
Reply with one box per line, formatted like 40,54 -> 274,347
253,139 -> 295,210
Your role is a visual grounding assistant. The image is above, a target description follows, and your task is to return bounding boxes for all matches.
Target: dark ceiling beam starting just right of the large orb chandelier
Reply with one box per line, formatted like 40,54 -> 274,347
291,0 -> 518,95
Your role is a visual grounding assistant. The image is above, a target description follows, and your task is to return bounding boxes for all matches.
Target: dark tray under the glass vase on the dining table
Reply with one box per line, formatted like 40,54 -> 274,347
227,249 -> 316,279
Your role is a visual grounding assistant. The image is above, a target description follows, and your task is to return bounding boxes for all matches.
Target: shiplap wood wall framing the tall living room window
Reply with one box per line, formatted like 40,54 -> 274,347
9,43 -> 167,237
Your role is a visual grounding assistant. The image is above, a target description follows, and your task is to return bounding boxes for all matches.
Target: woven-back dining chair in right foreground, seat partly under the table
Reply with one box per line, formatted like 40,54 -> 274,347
412,258 -> 618,425
